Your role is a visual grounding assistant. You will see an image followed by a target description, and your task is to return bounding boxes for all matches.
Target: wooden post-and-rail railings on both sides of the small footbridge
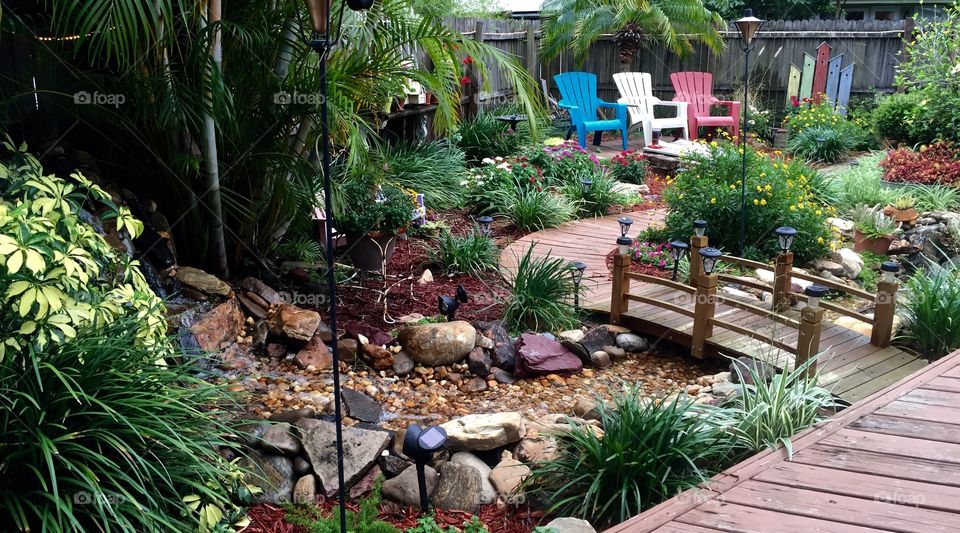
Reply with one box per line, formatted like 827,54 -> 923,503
610,230 -> 898,369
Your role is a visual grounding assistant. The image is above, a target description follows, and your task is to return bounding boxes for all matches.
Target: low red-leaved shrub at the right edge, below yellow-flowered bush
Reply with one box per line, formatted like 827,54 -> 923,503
880,141 -> 960,185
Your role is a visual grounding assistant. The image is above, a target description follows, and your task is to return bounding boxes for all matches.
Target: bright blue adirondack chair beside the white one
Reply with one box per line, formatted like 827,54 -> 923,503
553,72 -> 629,150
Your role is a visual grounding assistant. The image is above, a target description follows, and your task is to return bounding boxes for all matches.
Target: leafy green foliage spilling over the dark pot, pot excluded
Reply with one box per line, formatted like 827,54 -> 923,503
337,177 -> 417,235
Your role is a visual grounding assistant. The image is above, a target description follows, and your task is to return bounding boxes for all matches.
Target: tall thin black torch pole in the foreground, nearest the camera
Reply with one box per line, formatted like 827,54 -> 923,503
313,39 -> 347,533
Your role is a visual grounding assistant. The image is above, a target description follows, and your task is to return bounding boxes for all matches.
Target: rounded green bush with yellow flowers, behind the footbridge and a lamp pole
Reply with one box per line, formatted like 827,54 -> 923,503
663,142 -> 833,261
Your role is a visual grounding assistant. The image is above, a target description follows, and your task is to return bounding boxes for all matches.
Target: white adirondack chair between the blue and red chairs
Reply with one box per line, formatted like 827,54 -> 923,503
613,72 -> 690,144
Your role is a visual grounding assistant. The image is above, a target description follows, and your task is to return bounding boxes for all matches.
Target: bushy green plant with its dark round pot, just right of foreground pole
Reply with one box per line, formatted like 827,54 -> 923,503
337,178 -> 417,272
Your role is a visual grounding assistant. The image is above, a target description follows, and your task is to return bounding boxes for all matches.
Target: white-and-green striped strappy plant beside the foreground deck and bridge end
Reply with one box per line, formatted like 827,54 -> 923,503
711,358 -> 840,457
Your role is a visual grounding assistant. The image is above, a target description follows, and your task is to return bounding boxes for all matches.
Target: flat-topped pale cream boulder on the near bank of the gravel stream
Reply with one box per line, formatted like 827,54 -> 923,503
440,412 -> 527,451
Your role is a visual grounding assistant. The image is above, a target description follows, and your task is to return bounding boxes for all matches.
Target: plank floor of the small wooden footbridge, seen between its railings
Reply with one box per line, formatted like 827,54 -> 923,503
590,282 -> 927,403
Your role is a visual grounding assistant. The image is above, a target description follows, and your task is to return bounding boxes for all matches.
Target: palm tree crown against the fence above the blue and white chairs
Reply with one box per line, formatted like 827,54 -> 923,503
541,0 -> 724,70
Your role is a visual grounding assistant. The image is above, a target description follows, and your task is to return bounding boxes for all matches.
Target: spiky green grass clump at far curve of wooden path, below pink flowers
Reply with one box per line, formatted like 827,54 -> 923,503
493,188 -> 576,231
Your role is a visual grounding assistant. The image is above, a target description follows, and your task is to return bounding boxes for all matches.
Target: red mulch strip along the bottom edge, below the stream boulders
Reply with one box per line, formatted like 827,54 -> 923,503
243,500 -> 544,533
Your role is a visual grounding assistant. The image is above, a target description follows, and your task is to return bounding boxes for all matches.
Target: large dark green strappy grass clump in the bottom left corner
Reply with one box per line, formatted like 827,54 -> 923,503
0,316 -> 250,531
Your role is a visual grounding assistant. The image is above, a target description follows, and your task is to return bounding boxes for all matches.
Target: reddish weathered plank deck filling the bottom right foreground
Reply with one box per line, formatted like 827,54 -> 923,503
607,352 -> 960,533
